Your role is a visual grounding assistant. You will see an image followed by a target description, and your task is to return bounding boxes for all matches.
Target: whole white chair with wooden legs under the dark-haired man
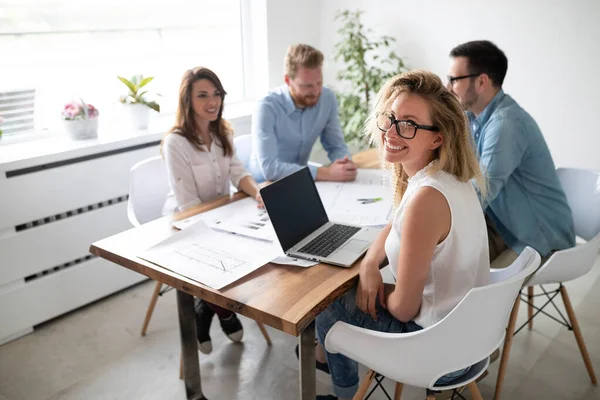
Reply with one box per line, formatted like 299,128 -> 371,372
494,168 -> 600,399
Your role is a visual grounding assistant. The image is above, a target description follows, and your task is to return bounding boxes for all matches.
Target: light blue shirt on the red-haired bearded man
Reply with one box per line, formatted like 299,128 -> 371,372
249,85 -> 350,182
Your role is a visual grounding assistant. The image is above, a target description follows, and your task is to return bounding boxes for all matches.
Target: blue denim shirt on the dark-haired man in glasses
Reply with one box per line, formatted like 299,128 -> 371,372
467,90 -> 575,257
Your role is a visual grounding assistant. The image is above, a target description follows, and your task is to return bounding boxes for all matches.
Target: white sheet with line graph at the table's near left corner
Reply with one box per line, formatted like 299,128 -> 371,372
139,222 -> 282,289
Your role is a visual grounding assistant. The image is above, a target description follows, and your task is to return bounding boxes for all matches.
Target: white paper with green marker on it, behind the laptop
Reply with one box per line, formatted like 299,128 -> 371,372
316,169 -> 393,226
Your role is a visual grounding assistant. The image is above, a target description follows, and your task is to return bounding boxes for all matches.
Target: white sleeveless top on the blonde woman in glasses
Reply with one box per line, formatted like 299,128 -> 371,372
385,161 -> 490,328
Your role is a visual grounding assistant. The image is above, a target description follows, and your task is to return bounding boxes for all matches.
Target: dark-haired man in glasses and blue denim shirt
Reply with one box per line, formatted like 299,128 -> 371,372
447,40 -> 575,267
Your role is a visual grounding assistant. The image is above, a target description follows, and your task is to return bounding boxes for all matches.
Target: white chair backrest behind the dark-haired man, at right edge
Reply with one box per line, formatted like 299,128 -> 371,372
556,168 -> 600,240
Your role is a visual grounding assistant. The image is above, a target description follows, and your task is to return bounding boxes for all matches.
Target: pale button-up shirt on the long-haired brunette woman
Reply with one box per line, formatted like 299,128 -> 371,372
162,133 -> 250,215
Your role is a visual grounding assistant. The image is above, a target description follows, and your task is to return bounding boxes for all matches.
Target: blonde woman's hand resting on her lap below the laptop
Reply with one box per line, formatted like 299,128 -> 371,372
356,258 -> 386,320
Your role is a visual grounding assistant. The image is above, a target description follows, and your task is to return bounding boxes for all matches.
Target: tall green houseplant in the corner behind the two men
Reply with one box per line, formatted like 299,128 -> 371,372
334,10 -> 405,146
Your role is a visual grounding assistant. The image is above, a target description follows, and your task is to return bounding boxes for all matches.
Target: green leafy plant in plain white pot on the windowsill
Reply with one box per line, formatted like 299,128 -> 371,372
117,75 -> 160,129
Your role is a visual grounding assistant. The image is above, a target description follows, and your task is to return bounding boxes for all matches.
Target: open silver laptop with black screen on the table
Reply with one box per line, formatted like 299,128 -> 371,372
260,167 -> 381,267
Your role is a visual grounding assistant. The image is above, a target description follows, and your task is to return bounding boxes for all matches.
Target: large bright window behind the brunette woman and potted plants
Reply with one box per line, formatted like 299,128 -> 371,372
0,0 -> 245,140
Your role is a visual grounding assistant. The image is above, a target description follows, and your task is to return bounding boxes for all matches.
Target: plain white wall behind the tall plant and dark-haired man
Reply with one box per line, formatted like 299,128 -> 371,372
318,0 -> 600,170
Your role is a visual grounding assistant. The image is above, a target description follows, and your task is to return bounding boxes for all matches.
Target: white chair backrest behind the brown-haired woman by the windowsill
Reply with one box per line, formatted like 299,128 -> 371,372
127,156 -> 170,226
